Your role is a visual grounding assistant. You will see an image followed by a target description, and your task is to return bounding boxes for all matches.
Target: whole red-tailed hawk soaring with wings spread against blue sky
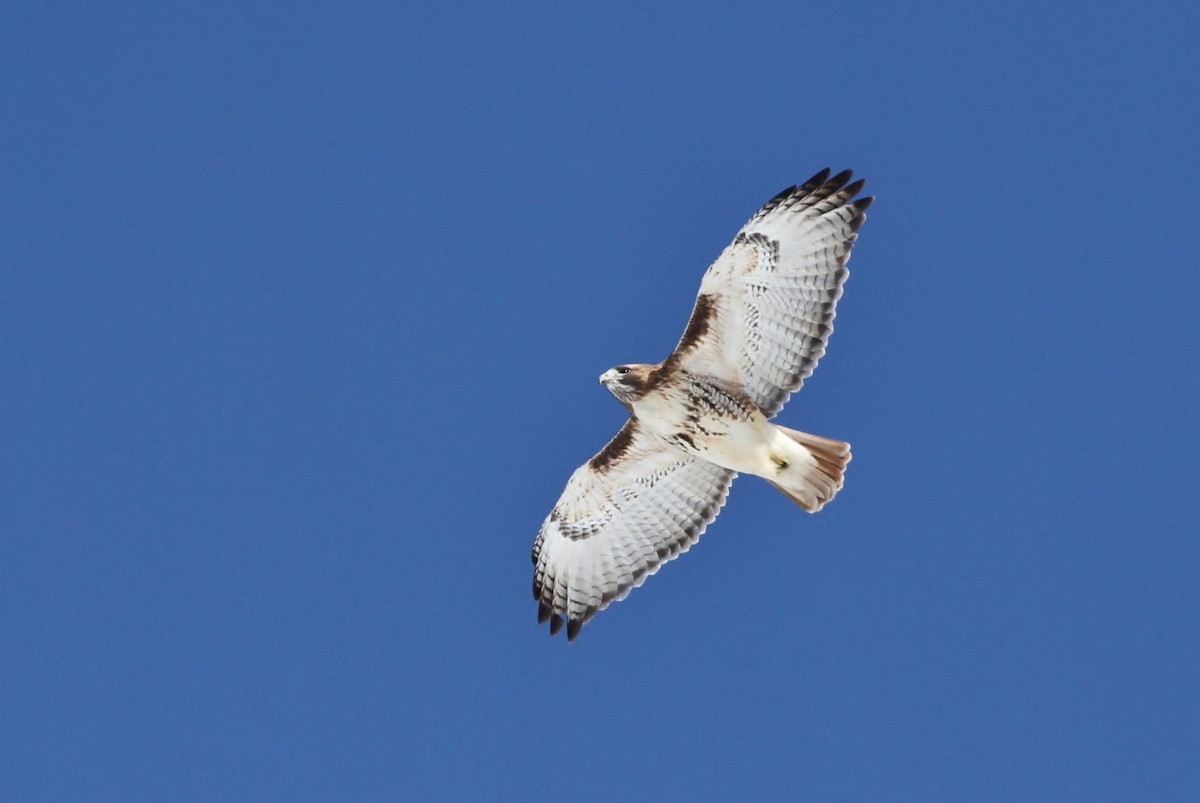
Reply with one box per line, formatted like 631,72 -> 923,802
533,169 -> 872,640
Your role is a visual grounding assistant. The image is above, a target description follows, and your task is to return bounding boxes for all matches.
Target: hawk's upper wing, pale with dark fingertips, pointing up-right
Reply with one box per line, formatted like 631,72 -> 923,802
666,169 -> 874,418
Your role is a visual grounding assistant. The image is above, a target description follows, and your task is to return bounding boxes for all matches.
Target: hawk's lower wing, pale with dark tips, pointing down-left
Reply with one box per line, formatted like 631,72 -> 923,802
533,418 -> 737,640
